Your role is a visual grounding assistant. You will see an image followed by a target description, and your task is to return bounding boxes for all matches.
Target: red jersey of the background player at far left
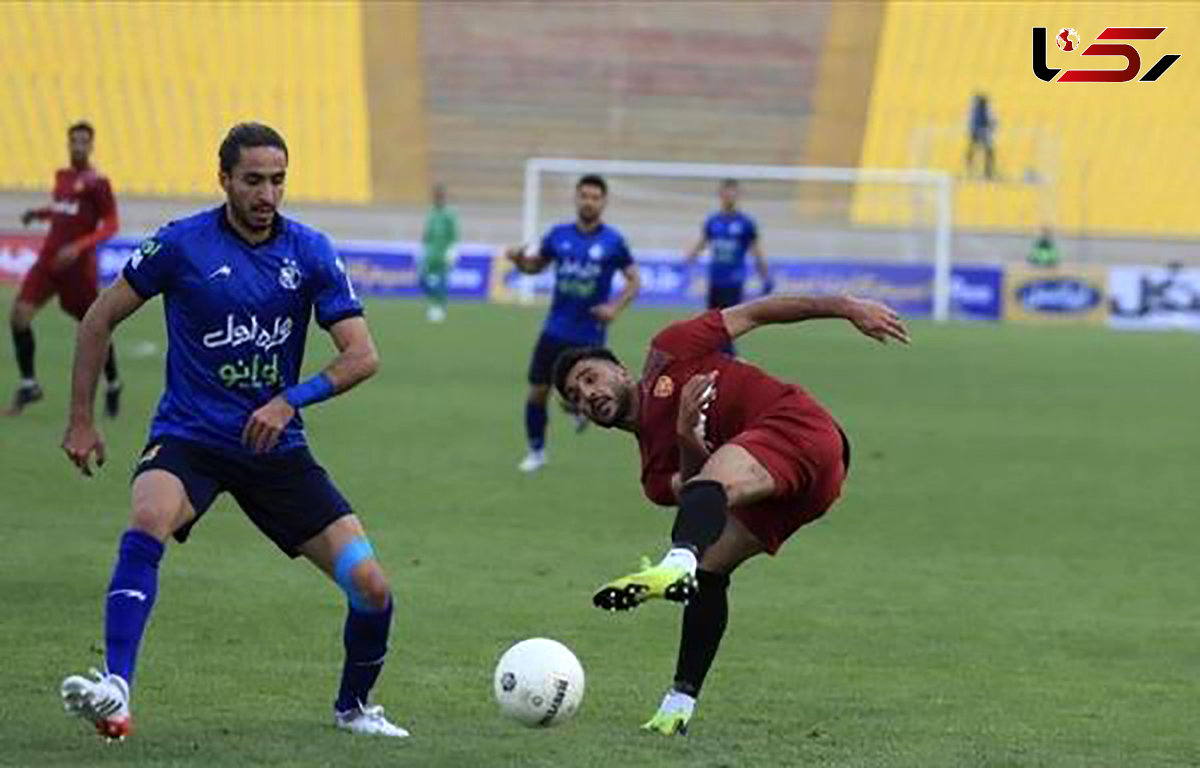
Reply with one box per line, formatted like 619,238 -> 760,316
36,168 -> 118,259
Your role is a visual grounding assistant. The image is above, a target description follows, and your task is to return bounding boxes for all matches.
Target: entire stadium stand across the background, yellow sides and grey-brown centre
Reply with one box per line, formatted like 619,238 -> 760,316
0,0 -> 1200,260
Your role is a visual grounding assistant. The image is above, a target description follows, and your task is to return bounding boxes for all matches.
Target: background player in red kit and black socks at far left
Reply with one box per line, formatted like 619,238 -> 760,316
8,122 -> 121,416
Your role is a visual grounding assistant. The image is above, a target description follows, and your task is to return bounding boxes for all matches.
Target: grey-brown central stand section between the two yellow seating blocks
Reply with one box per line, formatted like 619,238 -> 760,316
422,2 -> 829,200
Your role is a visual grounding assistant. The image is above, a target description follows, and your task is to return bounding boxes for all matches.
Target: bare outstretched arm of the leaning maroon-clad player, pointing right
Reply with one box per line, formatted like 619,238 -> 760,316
721,295 -> 908,344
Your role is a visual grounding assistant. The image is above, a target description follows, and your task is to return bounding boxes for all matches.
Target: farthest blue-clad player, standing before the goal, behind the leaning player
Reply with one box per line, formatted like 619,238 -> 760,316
684,179 -> 773,354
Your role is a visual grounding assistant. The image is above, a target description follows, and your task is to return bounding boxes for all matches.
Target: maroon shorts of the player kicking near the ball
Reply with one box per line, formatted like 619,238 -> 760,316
730,400 -> 850,554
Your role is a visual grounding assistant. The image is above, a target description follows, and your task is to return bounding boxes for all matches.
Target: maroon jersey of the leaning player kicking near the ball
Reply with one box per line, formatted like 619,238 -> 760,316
637,310 -> 838,506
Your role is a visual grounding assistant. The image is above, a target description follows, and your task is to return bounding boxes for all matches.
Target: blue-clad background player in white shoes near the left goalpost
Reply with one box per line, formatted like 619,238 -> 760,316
506,175 -> 641,472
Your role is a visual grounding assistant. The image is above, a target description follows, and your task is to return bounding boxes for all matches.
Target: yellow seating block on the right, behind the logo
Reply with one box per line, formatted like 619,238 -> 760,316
854,2 -> 1200,236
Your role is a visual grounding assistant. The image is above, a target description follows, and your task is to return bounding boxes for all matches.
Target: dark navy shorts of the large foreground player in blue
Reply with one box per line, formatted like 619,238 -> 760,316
133,437 -> 353,557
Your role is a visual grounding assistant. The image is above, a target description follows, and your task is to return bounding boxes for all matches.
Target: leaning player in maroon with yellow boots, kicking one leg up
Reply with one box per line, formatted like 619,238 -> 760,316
554,295 -> 908,734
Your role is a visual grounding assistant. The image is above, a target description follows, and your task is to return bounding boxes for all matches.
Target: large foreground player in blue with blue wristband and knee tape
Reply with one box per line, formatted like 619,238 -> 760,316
61,122 -> 408,738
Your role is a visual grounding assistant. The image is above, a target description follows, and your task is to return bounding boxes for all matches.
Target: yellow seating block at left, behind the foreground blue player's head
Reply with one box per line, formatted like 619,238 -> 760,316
0,2 -> 371,202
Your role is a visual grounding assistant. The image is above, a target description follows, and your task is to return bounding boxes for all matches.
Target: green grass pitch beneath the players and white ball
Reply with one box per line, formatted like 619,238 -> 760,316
0,290 -> 1200,768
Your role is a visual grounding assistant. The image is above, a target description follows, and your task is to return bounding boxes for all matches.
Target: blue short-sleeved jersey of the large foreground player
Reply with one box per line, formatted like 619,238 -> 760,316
122,208 -> 362,452
